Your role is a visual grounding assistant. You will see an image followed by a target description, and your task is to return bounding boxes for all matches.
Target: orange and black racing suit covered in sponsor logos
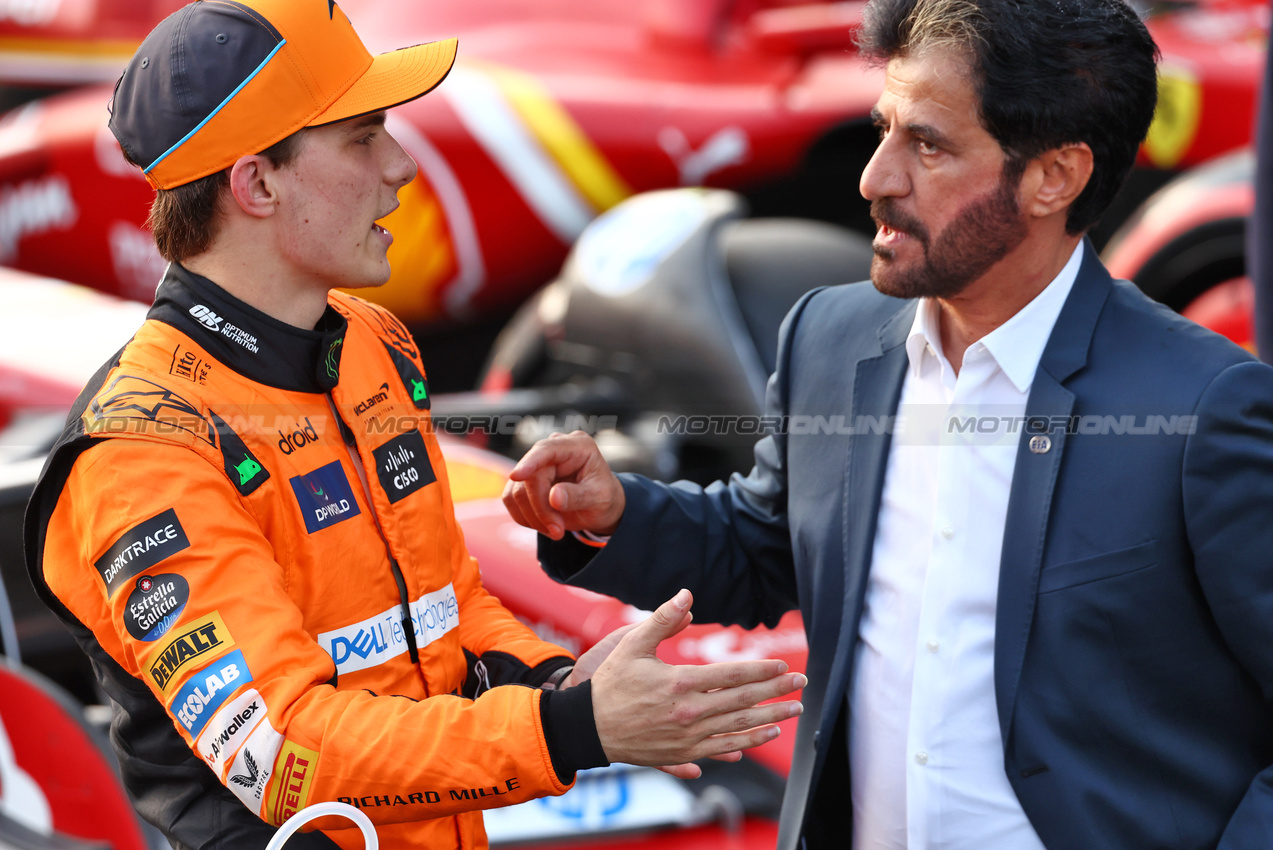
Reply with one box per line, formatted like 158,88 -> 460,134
27,265 -> 605,849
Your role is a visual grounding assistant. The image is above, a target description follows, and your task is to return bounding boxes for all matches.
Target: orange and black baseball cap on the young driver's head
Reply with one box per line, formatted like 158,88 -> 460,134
111,0 -> 456,188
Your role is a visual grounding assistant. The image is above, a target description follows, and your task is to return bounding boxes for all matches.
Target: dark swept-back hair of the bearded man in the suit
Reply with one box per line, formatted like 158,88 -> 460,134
858,0 -> 1158,235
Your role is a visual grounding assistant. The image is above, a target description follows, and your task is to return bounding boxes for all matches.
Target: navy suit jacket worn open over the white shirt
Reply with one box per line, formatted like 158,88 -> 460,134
541,244 -> 1273,850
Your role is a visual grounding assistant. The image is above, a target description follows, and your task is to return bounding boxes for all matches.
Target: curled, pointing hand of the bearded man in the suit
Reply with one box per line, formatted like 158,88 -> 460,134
504,431 -> 624,540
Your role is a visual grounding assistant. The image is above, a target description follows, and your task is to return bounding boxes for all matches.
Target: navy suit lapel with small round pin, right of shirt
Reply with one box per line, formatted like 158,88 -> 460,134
994,240 -> 1111,746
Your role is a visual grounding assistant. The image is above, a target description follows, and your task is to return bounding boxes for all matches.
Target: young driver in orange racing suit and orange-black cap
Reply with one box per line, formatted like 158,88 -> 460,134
19,0 -> 803,849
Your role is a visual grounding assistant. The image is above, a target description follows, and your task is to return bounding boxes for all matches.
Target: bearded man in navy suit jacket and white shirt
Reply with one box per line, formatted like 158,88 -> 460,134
505,0 -> 1273,850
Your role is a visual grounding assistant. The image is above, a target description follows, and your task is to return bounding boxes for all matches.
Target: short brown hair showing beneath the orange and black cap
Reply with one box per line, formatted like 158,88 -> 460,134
146,130 -> 304,262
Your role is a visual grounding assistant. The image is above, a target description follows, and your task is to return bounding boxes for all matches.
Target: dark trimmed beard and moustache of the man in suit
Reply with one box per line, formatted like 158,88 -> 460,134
871,170 -> 1026,298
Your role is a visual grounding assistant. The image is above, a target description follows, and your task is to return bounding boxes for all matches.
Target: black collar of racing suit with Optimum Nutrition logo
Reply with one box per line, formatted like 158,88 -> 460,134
146,263 -> 349,393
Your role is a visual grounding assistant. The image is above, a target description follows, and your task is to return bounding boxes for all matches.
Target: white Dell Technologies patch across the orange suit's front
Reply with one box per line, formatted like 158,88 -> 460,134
318,584 -> 460,674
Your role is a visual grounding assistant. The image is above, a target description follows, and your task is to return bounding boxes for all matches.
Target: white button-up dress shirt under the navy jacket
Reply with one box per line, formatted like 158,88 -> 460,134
849,244 -> 1083,850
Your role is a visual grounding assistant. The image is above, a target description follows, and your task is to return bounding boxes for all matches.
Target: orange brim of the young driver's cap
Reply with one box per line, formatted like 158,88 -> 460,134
307,38 -> 460,127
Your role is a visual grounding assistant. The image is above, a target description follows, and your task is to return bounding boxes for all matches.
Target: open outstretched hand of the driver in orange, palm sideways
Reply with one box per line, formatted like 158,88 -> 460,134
585,590 -> 806,779
